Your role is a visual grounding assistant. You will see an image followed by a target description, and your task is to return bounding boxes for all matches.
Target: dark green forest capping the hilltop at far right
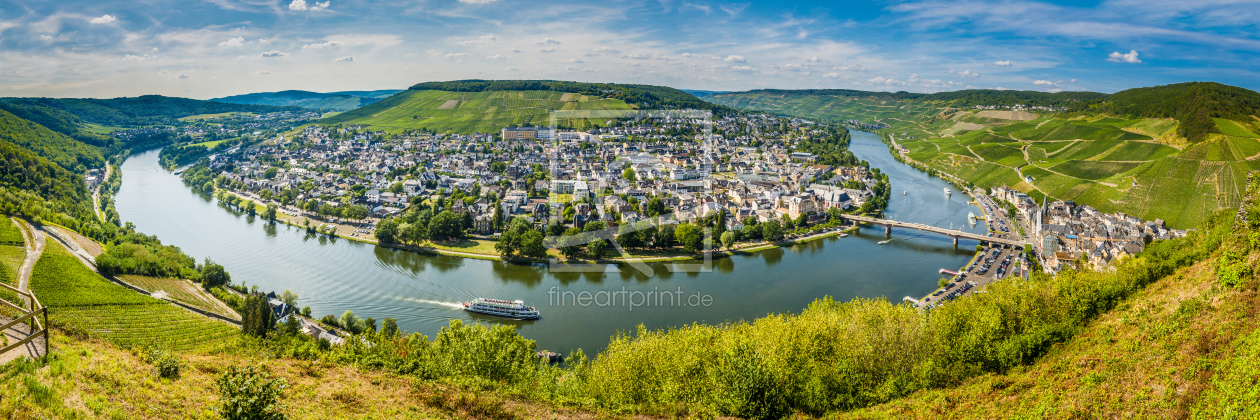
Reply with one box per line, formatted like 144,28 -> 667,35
1070,82 -> 1260,143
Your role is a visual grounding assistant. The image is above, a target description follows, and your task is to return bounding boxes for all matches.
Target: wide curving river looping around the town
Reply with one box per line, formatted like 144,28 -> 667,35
116,131 -> 984,356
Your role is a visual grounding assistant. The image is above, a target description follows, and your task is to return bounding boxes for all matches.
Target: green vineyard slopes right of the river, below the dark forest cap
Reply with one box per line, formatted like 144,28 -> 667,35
706,92 -> 1260,228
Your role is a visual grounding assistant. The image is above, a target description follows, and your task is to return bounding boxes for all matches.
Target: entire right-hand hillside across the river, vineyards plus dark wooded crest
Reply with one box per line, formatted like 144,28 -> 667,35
706,83 -> 1260,228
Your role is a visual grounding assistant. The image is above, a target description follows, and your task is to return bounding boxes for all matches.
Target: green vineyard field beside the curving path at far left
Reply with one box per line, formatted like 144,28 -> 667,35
30,241 -> 238,351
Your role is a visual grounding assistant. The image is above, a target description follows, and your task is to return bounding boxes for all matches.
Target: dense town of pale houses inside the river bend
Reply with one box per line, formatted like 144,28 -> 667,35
185,114 -> 888,253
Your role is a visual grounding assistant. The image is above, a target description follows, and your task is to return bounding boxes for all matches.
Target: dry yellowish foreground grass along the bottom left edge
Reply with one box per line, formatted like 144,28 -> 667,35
0,334 -> 564,419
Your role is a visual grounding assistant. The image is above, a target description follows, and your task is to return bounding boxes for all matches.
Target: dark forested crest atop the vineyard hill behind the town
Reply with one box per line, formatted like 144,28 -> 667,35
410,79 -> 738,112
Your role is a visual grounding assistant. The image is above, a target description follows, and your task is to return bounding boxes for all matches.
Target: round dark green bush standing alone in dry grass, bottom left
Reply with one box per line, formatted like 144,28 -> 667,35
214,366 -> 289,420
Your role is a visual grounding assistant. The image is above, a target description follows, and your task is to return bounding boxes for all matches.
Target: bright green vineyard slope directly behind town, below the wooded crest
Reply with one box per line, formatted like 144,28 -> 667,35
320,91 -> 630,134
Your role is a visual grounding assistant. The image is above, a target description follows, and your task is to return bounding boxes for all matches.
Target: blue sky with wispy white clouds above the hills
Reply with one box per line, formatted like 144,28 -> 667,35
0,0 -> 1260,98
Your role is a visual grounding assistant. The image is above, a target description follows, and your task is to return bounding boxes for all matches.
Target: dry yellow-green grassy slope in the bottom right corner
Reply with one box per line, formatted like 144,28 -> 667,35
835,248 -> 1260,419
